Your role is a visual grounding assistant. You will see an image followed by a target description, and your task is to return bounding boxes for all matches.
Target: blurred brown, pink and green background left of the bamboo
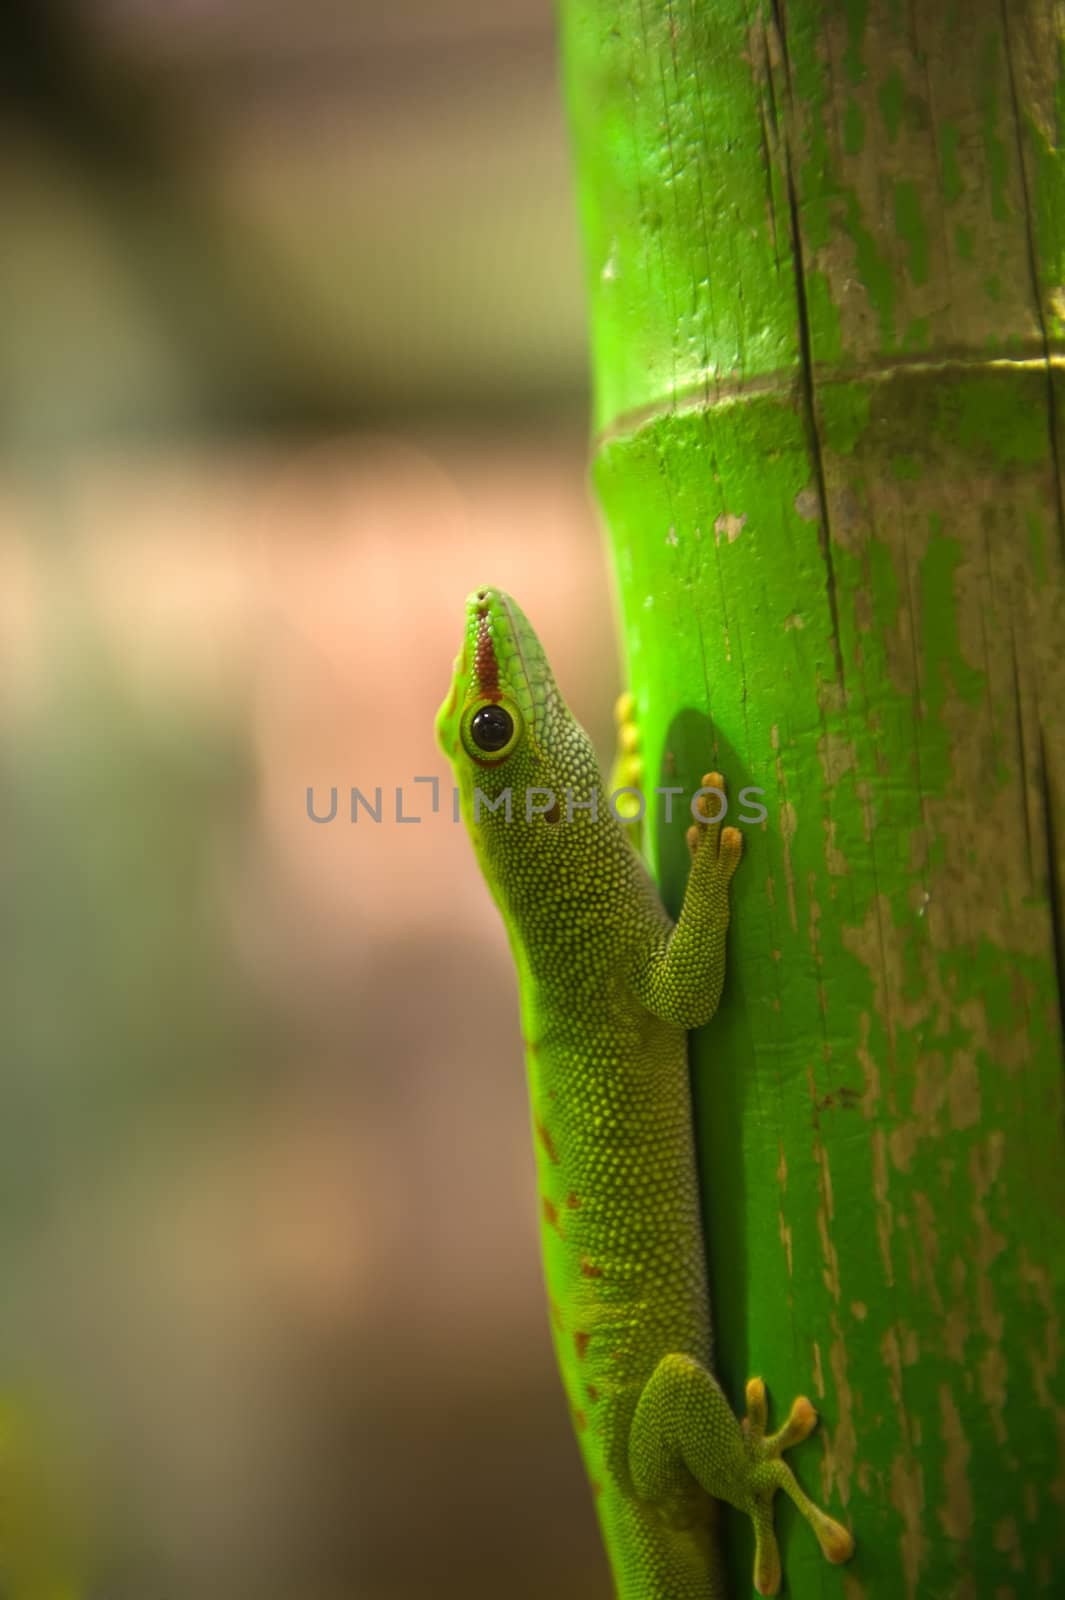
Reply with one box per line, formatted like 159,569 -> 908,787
0,0 -> 617,1600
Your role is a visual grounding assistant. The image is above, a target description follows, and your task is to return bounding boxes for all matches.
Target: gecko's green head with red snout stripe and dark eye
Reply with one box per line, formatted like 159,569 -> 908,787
437,587 -> 600,883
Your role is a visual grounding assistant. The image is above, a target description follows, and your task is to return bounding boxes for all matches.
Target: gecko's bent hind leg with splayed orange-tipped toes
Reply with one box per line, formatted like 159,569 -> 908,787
628,1355 -> 854,1595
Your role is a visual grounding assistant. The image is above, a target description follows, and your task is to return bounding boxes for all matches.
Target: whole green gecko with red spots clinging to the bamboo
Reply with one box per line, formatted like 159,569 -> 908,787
437,589 -> 854,1600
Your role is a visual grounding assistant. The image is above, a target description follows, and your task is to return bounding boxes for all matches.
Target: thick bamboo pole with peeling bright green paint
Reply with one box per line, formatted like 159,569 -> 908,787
561,0 -> 1065,1600
